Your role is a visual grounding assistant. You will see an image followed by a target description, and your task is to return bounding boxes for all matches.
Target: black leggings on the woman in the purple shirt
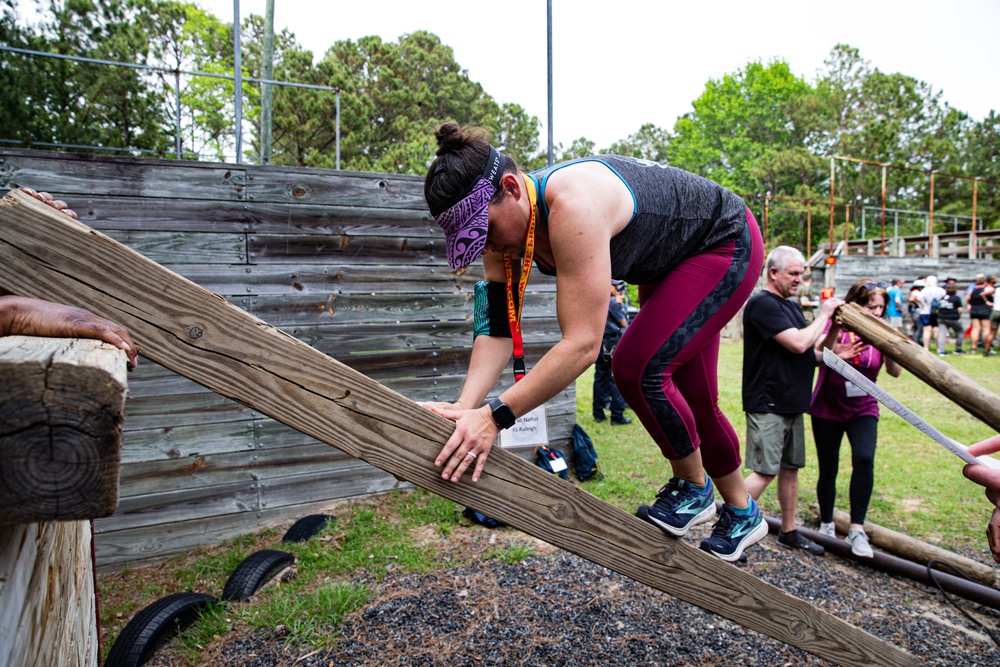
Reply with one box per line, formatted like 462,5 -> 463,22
812,417 -> 878,525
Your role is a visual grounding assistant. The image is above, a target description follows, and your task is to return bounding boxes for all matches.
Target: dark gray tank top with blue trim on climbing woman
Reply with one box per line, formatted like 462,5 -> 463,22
530,155 -> 747,285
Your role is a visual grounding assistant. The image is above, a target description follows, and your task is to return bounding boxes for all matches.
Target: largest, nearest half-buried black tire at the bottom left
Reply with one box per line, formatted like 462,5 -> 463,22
104,593 -> 218,667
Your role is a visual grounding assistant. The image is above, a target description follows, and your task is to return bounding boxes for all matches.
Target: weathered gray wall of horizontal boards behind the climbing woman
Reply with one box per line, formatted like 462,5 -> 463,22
0,149 -> 576,567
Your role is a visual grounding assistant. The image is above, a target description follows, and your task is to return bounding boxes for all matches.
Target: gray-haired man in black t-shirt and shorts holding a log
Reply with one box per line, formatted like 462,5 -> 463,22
743,246 -> 844,556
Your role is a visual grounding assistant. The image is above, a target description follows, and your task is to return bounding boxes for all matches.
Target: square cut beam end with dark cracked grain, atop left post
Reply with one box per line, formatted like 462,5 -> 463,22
0,336 -> 127,525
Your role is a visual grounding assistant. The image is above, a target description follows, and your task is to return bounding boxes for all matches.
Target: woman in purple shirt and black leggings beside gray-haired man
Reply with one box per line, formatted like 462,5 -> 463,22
809,280 -> 902,558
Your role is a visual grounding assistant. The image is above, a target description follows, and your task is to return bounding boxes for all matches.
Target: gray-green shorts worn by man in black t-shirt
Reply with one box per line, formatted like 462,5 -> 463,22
744,412 -> 806,476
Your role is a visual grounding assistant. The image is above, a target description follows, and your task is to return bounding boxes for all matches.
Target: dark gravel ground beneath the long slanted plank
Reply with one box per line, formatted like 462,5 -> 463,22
149,526 -> 1000,667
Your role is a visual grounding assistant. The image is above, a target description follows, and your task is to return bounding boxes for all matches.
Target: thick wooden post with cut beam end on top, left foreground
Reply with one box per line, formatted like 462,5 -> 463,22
0,336 -> 127,667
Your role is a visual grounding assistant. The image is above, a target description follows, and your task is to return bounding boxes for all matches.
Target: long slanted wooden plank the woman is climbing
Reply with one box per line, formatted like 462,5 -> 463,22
0,191 -> 917,665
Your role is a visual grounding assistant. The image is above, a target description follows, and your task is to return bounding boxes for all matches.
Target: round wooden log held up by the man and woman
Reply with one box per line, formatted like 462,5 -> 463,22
837,303 -> 1000,432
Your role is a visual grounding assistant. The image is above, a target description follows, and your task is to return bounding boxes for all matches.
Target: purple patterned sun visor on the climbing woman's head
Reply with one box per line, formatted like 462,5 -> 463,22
434,146 -> 506,269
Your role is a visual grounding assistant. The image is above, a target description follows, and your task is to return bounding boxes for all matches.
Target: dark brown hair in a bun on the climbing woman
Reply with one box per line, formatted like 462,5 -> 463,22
424,123 -> 519,210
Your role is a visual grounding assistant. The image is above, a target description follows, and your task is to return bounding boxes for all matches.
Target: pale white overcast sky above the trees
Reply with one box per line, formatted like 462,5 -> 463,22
125,0 -> 1000,149
